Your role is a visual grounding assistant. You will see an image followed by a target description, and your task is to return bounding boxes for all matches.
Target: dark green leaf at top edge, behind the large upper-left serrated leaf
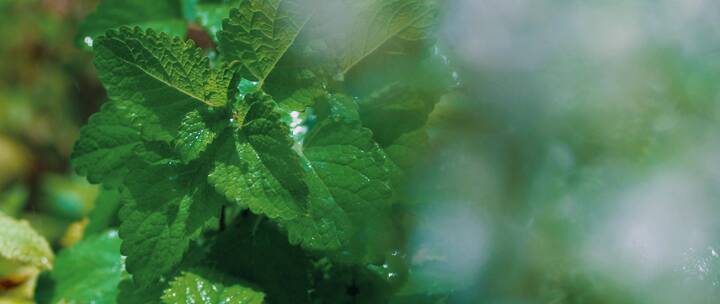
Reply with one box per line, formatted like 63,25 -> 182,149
76,0 -> 187,47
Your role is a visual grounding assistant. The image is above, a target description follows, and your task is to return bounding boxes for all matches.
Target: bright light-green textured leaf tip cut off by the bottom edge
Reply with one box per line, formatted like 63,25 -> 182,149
162,272 -> 265,304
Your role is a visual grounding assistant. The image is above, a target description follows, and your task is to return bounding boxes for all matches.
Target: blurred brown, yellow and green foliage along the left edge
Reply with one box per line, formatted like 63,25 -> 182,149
0,0 -> 104,303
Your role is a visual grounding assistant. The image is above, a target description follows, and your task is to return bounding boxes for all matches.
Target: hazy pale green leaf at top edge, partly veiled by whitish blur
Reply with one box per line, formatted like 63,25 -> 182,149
272,0 -> 438,80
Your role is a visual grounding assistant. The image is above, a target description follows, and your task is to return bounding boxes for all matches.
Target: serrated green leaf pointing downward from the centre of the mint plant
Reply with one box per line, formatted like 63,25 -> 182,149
208,92 -> 308,219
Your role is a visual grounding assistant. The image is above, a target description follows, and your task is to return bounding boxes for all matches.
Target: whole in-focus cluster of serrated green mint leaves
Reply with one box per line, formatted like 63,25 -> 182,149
38,0 -> 452,303
